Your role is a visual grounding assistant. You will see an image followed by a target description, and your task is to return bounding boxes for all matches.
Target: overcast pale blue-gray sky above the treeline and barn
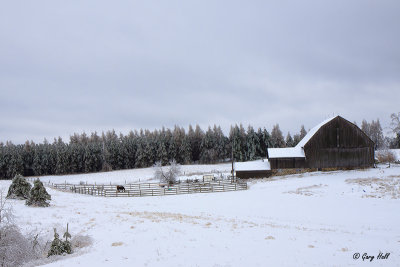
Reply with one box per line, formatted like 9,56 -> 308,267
0,0 -> 400,143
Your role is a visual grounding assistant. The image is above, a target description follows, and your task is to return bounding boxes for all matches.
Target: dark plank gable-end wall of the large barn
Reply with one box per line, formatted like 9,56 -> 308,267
304,117 -> 374,168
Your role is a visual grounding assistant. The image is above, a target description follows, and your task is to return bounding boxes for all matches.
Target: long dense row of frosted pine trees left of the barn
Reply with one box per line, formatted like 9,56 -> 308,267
0,124 -> 306,179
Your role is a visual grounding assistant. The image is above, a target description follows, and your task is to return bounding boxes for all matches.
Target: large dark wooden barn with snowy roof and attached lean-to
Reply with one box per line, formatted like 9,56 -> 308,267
267,116 -> 374,169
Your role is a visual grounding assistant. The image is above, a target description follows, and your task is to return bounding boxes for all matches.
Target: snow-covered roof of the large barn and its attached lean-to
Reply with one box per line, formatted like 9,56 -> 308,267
268,117 -> 336,159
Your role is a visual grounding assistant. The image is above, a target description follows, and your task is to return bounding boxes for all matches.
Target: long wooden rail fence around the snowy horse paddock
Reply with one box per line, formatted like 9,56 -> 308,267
49,180 -> 247,197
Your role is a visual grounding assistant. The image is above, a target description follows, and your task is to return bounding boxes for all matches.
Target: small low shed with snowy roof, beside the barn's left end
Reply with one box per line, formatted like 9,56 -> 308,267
234,160 -> 271,179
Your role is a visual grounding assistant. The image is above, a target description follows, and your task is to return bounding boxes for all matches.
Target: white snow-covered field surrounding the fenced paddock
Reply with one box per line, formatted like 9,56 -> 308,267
0,164 -> 400,267
